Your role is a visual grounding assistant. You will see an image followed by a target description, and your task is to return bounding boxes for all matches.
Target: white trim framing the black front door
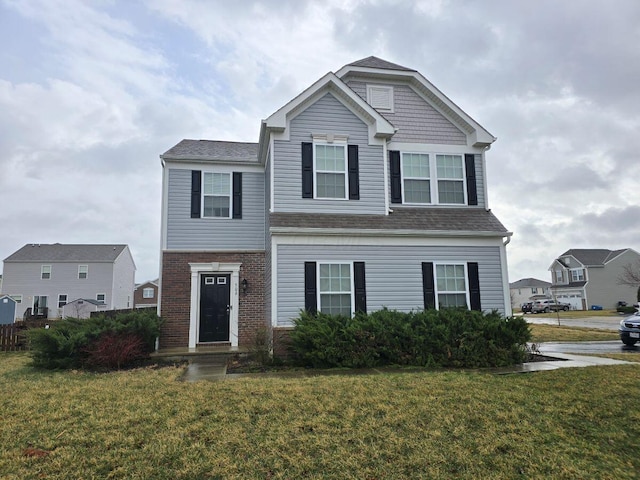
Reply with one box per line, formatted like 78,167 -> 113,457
189,262 -> 242,348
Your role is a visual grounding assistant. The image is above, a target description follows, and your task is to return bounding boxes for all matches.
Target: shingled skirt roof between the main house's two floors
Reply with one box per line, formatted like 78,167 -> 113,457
269,208 -> 508,234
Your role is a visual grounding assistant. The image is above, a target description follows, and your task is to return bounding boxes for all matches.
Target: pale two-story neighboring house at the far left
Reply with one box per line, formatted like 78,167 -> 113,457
2,243 -> 136,318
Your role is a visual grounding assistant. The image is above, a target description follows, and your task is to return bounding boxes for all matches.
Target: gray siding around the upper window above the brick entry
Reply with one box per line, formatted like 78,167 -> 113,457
167,168 -> 265,250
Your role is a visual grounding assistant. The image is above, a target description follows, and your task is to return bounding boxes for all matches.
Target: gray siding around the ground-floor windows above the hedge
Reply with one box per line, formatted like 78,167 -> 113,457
277,245 -> 505,326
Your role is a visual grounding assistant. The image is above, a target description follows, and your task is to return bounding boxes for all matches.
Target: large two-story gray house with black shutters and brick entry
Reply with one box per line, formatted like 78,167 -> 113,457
160,57 -> 511,351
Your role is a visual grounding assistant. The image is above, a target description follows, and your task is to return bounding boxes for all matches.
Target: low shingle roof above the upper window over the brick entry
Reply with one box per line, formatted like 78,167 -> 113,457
161,139 -> 258,163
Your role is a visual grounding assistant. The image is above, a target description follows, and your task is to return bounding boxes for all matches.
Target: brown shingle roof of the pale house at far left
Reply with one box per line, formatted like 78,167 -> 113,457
4,243 -> 128,263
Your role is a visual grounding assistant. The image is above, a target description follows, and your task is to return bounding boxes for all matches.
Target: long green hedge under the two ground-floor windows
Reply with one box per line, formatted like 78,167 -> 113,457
290,308 -> 531,368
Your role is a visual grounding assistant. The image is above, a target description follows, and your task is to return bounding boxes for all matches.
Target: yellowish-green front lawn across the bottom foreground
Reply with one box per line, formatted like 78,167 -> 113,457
0,353 -> 640,479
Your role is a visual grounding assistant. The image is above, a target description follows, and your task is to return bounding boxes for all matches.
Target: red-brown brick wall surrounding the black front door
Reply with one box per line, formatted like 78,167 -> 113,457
160,252 -> 267,348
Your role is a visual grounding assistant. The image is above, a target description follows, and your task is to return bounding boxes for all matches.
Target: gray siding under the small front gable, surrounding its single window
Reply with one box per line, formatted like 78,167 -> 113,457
273,94 -> 384,214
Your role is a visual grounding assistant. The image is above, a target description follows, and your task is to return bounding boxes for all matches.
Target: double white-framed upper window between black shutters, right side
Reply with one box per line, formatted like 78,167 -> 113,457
398,152 -> 468,205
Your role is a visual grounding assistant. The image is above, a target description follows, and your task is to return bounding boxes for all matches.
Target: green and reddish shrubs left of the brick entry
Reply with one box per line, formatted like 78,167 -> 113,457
27,310 -> 162,369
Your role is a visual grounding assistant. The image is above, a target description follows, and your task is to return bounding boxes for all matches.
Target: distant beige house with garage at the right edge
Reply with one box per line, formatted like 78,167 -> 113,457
549,248 -> 640,310
